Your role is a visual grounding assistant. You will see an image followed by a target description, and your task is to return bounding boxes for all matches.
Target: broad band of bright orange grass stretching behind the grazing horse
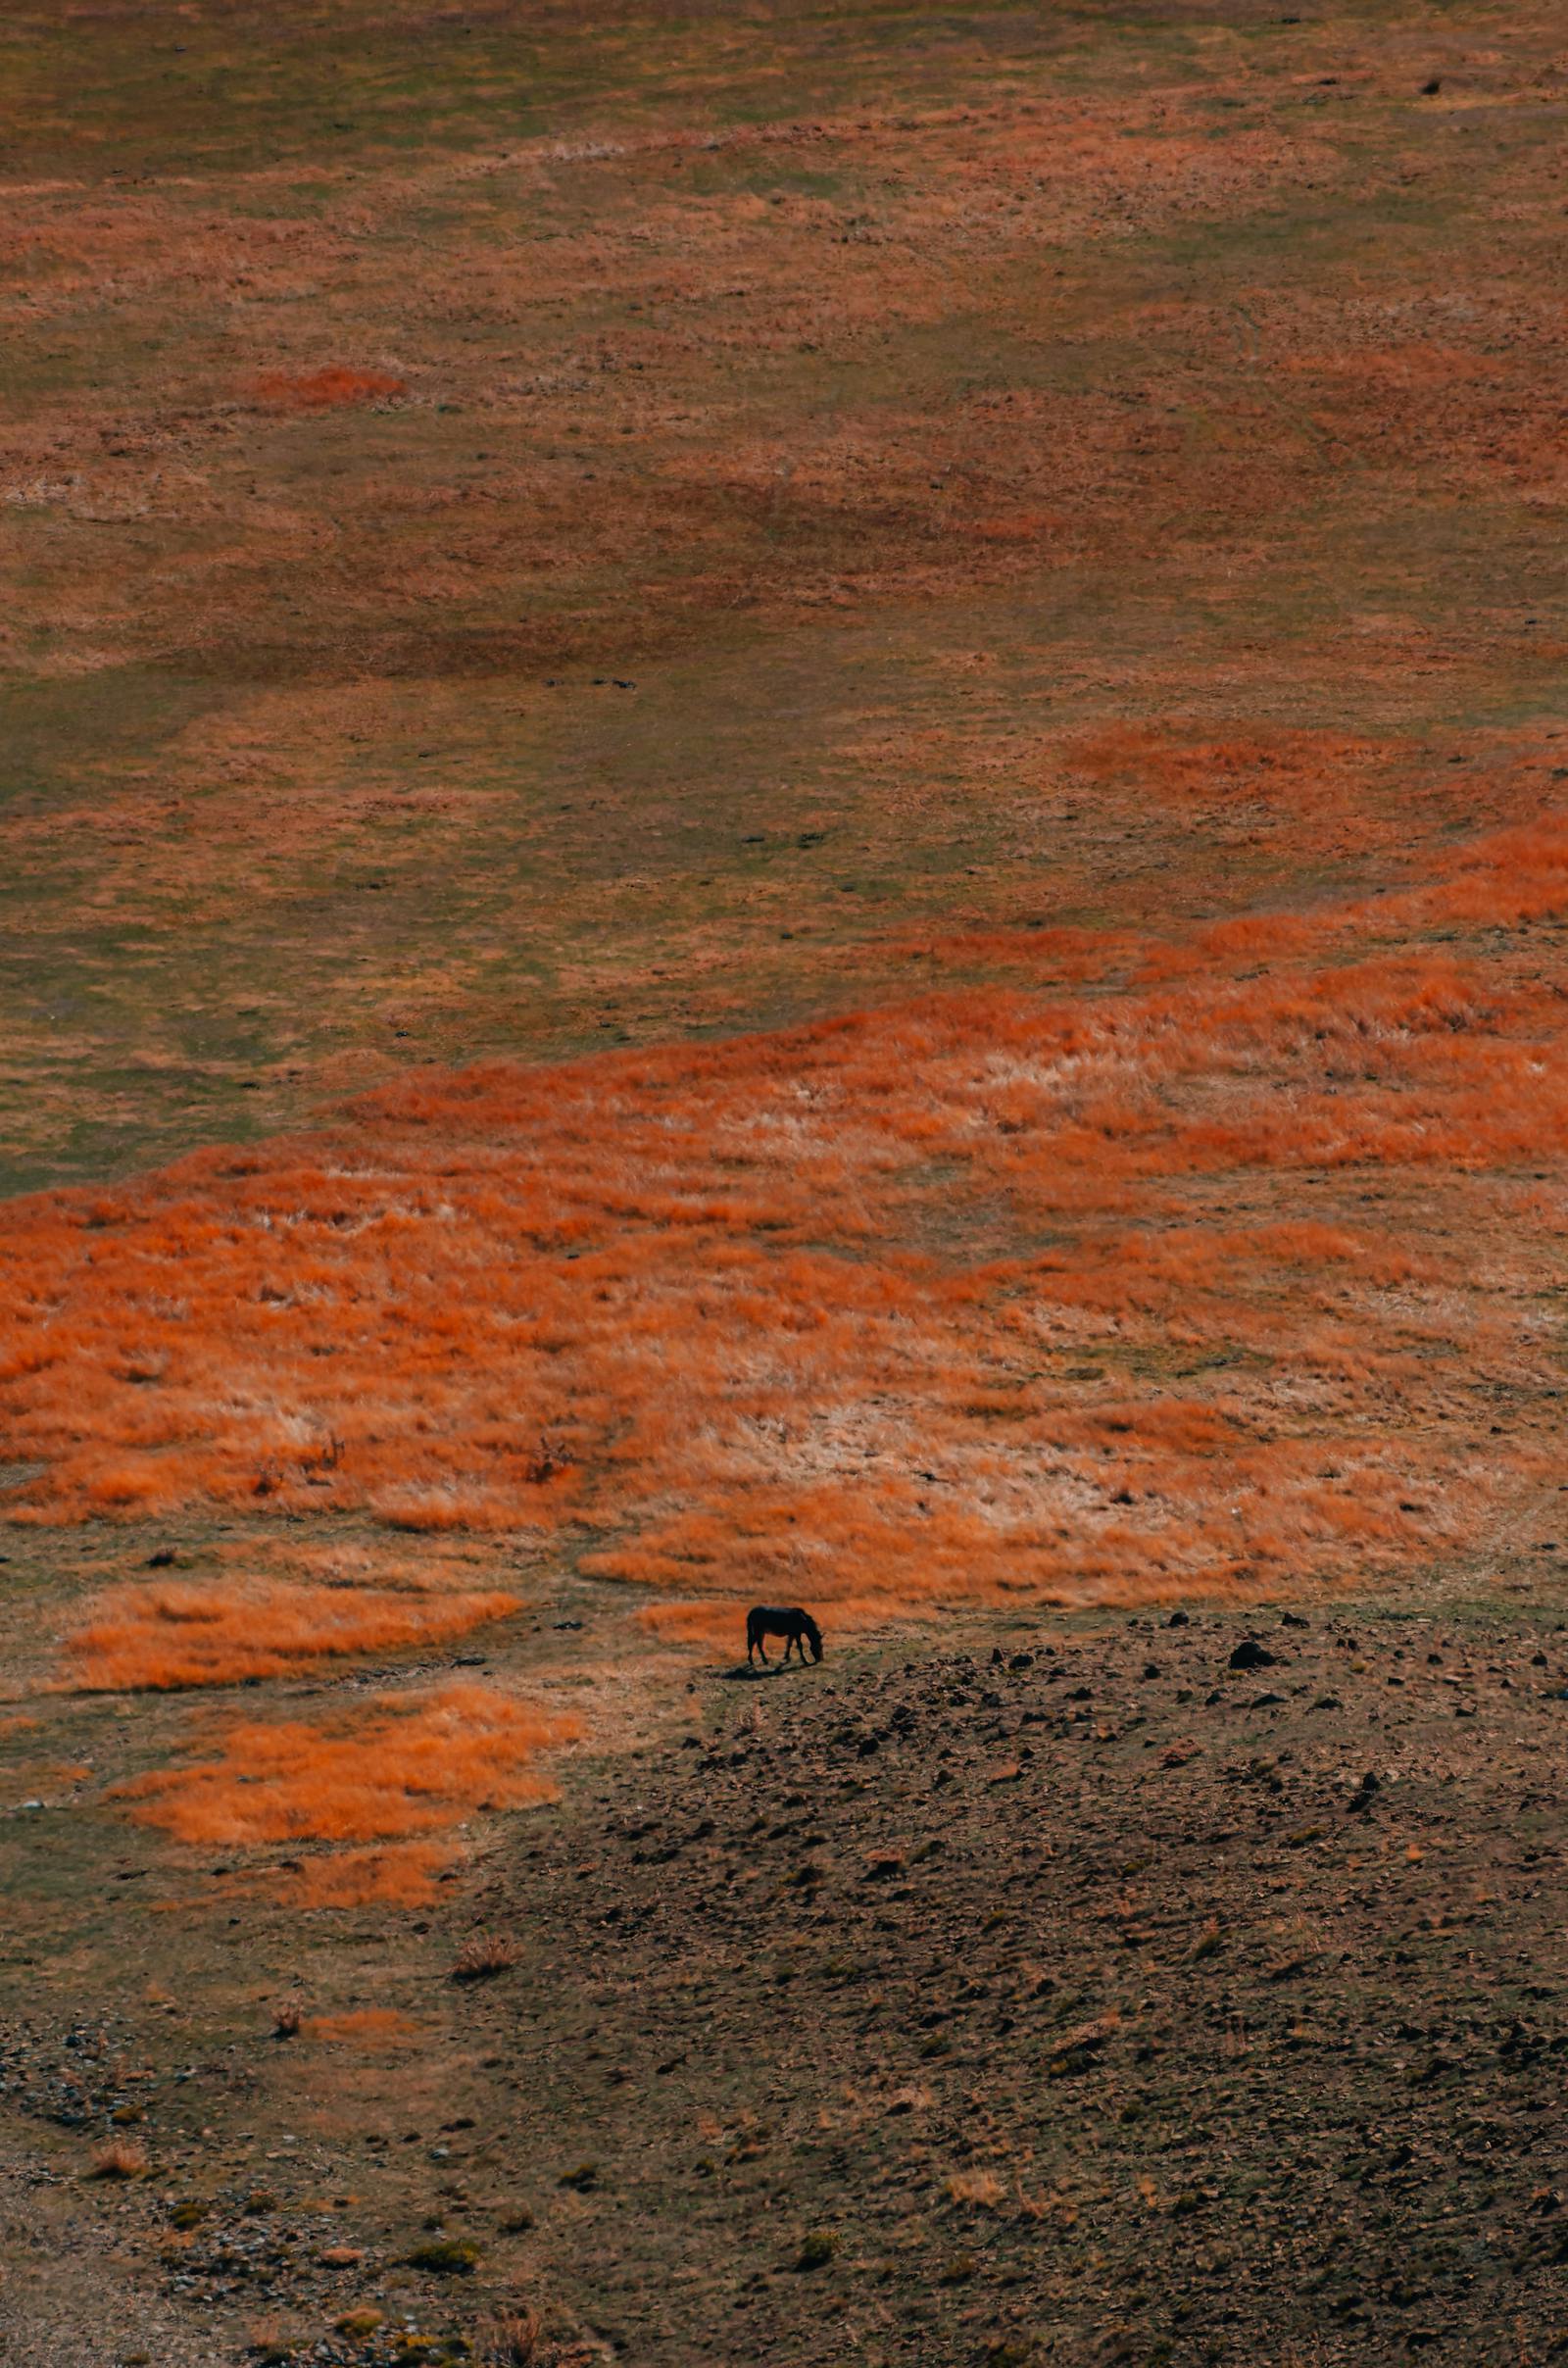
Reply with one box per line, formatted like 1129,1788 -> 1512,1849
0,817 -> 1568,1619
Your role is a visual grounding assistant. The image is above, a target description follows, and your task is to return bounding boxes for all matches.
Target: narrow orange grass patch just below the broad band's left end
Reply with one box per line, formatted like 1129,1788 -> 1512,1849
67,1579 -> 521,1693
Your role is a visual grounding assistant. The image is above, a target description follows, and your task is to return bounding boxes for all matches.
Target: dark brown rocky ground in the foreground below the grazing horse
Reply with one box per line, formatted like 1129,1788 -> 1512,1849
0,1605 -> 1568,2368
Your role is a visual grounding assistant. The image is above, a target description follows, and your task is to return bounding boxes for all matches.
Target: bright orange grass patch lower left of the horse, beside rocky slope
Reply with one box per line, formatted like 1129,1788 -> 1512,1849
112,1684 -> 580,1847
